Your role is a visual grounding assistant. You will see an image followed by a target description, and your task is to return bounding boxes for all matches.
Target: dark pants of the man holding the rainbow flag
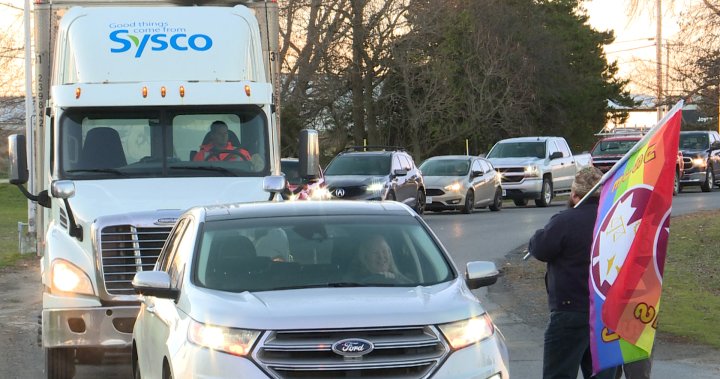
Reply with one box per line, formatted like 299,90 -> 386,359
543,311 -> 615,379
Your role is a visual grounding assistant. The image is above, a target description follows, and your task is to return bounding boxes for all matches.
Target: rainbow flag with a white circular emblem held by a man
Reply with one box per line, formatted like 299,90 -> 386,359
589,101 -> 683,373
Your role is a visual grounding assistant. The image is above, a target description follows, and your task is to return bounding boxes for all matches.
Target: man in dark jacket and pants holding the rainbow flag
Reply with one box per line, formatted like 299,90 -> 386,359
528,167 -> 615,379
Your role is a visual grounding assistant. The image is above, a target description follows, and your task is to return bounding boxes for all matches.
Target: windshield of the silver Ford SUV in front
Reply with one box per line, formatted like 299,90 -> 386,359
193,215 -> 455,292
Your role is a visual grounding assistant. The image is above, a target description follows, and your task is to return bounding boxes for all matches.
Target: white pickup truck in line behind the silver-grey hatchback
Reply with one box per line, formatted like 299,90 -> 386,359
487,137 -> 592,207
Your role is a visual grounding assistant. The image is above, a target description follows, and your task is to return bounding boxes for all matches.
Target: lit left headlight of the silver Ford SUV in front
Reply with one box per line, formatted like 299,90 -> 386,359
188,320 -> 260,357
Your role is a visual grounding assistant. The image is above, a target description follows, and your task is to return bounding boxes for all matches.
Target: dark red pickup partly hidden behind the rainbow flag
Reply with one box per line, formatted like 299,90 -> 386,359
590,134 -> 684,195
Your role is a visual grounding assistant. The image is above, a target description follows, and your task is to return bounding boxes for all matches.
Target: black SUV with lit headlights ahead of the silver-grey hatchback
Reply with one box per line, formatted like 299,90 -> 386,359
325,146 -> 425,214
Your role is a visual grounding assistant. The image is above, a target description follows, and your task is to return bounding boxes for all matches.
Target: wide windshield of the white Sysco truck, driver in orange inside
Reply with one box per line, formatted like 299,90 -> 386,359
56,106 -> 270,180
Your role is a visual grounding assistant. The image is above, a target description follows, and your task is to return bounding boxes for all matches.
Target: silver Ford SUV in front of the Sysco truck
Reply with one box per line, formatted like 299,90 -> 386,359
132,201 -> 508,379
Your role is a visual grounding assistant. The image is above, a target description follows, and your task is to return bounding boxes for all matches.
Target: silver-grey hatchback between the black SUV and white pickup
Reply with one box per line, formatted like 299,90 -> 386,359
420,155 -> 503,213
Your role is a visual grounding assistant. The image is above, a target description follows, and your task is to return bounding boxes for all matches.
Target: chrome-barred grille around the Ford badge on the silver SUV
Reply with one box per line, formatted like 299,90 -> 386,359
253,326 -> 449,379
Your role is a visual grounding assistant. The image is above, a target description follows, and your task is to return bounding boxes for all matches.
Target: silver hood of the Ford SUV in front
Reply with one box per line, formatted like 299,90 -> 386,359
188,278 -> 484,330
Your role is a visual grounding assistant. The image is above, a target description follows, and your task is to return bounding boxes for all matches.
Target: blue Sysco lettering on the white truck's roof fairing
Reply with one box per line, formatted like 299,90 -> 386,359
110,29 -> 212,58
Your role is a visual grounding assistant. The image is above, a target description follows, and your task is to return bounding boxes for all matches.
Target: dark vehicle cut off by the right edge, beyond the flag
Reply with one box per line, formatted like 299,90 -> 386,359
680,130 -> 720,192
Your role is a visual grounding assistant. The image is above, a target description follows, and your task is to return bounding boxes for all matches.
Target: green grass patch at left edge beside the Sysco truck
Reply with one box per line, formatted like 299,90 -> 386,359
0,183 -> 36,268
